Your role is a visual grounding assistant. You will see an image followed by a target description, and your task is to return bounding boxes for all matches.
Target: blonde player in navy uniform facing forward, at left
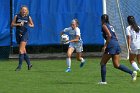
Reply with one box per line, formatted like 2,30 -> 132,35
11,6 -> 34,71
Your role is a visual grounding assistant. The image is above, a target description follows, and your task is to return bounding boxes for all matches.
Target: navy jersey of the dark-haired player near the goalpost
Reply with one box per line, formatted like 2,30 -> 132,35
102,24 -> 119,48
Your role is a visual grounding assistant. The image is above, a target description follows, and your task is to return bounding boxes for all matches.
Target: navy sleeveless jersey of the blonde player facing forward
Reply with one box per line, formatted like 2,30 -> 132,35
16,14 -> 29,34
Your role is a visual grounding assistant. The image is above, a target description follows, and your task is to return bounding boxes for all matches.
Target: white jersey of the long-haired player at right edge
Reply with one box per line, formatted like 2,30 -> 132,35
126,26 -> 140,50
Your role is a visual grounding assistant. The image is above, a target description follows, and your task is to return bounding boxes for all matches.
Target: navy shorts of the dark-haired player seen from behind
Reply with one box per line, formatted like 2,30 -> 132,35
105,46 -> 121,55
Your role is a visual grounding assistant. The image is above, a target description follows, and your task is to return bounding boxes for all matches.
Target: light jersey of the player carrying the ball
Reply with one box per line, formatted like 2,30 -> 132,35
63,27 -> 82,43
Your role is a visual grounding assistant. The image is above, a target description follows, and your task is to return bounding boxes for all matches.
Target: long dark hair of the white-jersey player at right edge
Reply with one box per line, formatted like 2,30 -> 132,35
127,16 -> 140,33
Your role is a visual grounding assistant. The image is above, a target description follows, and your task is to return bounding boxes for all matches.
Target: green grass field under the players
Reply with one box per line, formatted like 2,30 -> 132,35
0,58 -> 140,93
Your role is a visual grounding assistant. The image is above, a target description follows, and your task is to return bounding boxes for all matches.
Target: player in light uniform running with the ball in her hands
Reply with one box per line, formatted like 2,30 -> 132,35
61,19 -> 85,72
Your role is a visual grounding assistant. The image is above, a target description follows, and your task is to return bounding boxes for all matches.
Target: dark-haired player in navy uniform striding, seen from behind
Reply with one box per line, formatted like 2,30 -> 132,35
98,14 -> 137,84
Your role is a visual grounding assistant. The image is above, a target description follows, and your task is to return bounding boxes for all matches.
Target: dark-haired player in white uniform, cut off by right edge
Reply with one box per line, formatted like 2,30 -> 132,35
126,16 -> 140,75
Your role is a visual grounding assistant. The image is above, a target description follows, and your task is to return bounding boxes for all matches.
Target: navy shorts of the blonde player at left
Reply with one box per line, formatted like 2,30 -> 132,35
16,32 -> 28,44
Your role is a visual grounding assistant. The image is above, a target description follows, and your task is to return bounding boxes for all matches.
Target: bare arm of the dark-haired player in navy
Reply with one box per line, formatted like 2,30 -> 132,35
102,25 -> 111,51
